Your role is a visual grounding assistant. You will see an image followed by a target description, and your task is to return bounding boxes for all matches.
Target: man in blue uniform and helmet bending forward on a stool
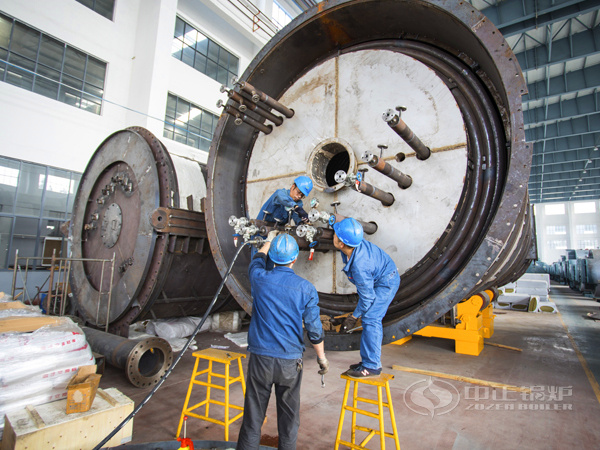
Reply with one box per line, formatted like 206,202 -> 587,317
333,218 -> 400,378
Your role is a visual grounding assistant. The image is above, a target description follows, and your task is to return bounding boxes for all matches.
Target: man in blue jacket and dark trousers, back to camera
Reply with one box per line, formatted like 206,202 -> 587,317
236,230 -> 329,450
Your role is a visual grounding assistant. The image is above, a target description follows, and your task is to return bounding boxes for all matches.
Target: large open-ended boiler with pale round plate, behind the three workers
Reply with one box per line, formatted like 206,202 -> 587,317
207,0 -> 532,349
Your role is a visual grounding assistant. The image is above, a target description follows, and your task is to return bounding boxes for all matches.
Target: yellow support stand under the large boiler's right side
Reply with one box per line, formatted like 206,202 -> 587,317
393,290 -> 496,356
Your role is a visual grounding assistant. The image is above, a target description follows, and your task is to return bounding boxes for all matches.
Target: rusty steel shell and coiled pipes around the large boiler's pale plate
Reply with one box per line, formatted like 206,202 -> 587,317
206,0 -> 532,350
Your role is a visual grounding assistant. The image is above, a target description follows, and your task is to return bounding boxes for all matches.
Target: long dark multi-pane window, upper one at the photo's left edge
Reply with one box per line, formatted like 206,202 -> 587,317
0,13 -> 106,114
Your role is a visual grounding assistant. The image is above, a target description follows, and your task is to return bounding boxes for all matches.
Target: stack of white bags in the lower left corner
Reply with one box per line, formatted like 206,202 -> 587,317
0,318 -> 95,436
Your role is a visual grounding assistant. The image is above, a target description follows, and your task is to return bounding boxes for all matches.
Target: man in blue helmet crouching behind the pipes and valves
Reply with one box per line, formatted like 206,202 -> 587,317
256,175 -> 313,225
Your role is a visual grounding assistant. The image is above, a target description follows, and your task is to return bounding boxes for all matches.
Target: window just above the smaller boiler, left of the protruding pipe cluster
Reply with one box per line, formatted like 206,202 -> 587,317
163,93 -> 219,151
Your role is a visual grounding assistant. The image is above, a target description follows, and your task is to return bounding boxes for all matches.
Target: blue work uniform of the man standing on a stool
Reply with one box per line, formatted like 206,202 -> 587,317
342,239 -> 400,370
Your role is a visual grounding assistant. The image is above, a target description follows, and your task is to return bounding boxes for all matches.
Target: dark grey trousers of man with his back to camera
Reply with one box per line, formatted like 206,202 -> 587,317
236,353 -> 302,450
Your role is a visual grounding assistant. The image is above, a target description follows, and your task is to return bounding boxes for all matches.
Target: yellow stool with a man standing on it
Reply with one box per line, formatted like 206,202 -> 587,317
335,373 -> 400,450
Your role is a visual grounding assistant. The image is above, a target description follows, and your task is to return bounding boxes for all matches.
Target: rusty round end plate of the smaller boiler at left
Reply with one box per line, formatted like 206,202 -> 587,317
71,128 -> 177,327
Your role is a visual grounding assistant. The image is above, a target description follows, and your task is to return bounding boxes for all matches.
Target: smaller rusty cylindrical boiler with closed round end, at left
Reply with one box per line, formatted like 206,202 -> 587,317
70,127 -> 232,336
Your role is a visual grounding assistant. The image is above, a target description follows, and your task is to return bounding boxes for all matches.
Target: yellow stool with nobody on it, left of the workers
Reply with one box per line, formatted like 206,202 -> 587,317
176,348 -> 246,441
